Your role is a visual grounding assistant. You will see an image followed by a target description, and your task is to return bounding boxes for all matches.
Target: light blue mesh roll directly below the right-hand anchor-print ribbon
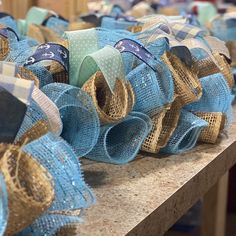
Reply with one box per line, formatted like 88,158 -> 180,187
127,61 -> 174,117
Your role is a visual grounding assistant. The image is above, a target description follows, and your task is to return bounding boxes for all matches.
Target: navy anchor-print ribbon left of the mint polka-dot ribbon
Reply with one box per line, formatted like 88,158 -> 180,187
24,43 -> 69,72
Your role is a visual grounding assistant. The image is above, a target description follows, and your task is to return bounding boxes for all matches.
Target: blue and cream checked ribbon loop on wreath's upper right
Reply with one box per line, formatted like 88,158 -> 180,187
170,23 -> 207,41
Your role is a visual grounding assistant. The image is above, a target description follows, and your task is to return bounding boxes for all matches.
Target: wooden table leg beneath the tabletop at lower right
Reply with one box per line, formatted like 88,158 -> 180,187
201,172 -> 229,236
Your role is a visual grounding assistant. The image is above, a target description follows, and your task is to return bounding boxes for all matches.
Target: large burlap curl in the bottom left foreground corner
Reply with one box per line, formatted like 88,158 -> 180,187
0,144 -> 54,235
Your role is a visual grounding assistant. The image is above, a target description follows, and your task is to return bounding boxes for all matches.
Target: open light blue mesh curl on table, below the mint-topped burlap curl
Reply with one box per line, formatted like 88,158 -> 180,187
86,113 -> 152,165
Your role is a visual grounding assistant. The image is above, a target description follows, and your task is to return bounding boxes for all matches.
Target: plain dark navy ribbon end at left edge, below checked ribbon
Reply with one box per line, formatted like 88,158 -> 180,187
0,87 -> 27,143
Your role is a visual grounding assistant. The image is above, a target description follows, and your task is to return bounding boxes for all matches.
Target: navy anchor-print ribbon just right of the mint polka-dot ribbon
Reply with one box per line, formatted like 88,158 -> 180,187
115,39 -> 158,71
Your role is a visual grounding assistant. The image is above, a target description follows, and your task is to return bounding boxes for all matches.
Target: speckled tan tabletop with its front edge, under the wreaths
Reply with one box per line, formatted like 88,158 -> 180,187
77,112 -> 236,236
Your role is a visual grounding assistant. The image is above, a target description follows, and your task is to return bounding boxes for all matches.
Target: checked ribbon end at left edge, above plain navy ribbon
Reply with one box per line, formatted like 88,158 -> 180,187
0,75 -> 34,105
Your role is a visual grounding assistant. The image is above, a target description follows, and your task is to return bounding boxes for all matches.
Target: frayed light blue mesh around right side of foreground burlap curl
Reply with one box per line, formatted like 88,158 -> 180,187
19,133 -> 95,236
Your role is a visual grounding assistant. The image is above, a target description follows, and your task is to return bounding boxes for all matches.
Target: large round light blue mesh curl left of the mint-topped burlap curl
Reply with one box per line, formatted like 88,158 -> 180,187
42,83 -> 100,156
